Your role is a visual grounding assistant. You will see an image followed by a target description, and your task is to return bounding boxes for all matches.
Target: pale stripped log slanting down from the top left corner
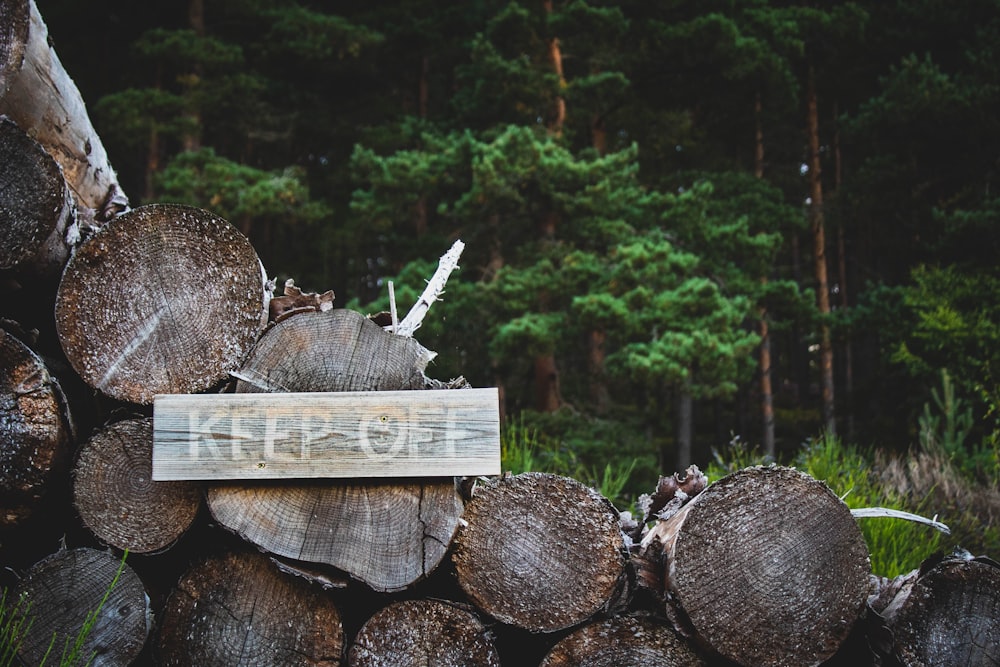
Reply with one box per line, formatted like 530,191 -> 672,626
0,0 -> 128,224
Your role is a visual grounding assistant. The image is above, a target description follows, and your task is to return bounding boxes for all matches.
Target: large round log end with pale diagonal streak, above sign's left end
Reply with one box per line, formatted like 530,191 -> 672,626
56,204 -> 267,404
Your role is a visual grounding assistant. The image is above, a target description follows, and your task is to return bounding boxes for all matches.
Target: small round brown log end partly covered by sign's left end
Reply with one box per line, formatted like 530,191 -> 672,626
73,419 -> 201,553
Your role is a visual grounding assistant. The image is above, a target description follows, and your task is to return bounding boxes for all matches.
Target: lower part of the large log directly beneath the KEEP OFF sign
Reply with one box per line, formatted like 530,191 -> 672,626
208,478 -> 463,592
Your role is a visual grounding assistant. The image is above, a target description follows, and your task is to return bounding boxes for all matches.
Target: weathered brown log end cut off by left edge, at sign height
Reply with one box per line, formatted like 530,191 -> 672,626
0,329 -> 71,528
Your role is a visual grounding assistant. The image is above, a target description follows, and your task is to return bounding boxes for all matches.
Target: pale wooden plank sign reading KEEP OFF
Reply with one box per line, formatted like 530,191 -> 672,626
153,389 -> 500,481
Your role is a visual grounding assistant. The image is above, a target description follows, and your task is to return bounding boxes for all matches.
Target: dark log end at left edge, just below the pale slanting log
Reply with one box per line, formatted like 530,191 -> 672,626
0,116 -> 79,275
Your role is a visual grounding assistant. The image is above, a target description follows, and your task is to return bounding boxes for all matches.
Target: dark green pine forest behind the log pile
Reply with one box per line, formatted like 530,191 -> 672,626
38,0 -> 1000,489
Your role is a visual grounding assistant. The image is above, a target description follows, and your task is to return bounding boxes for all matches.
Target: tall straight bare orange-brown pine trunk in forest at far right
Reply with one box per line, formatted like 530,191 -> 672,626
806,67 -> 837,437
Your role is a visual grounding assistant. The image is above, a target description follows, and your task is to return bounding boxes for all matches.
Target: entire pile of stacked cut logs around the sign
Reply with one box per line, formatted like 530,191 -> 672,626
0,0 -> 1000,667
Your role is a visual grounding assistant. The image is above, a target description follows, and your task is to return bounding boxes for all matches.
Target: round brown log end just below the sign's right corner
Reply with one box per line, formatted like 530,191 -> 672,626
453,473 -> 625,632
